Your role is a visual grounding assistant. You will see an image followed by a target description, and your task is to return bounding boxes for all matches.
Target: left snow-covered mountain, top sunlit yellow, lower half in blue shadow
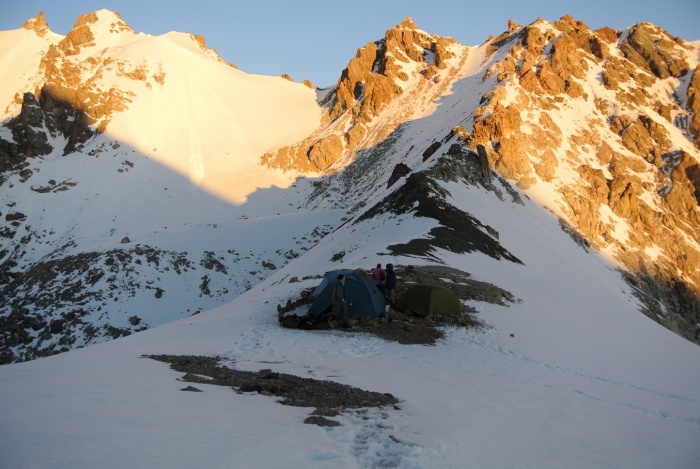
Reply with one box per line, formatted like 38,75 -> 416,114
0,10 -> 328,362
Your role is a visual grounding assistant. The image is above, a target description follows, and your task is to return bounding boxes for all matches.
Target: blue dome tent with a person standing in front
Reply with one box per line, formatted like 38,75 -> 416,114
308,270 -> 386,319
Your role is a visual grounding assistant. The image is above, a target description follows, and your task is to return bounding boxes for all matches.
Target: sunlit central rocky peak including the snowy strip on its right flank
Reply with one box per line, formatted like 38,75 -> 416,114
262,18 -> 468,172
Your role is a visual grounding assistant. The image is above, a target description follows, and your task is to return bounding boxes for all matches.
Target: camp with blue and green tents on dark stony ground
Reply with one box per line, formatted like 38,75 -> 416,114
277,266 -> 508,345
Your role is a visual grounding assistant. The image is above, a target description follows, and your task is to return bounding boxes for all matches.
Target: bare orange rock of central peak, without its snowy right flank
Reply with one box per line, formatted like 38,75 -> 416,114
262,18 -> 456,171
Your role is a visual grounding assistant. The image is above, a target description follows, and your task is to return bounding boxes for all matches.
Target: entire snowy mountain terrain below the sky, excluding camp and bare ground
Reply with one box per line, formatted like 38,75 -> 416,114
0,10 -> 700,468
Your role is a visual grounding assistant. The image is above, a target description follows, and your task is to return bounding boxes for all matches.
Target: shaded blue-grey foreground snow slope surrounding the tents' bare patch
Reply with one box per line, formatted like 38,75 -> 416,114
0,166 -> 700,468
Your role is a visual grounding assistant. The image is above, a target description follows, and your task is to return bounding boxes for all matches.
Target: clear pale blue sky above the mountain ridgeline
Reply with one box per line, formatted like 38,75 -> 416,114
0,0 -> 700,87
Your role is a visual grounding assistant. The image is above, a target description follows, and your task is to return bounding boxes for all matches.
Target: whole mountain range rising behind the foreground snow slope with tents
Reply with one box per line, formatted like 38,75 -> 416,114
0,10 -> 700,363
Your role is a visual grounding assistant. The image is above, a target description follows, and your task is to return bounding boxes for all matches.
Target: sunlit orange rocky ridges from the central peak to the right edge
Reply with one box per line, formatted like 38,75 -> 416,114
263,16 -> 700,340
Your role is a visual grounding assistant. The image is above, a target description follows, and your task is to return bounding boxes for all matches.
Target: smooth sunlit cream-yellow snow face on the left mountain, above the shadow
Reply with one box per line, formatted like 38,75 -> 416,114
104,29 -> 321,204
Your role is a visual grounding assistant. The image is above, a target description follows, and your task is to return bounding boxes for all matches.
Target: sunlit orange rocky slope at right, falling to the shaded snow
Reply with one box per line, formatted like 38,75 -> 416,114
472,17 -> 700,340
